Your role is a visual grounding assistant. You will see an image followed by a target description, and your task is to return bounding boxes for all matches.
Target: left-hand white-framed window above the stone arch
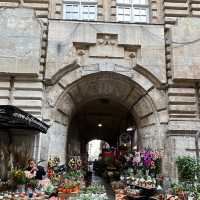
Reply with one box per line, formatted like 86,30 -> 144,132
63,0 -> 97,21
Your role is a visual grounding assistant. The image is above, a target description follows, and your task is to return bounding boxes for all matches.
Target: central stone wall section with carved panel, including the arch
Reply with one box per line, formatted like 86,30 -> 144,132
42,20 -> 168,166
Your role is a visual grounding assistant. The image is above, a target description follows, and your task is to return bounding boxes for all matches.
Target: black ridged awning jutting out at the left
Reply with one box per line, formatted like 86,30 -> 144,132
0,105 -> 49,133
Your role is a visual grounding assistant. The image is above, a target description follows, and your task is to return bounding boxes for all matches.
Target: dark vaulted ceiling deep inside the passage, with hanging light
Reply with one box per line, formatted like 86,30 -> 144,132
68,98 -> 134,144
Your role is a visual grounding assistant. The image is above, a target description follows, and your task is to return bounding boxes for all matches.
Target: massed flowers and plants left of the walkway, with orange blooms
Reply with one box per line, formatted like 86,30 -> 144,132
0,156 -> 109,200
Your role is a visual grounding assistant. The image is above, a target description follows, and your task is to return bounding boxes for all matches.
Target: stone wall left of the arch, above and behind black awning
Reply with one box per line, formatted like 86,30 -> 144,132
0,7 -> 44,162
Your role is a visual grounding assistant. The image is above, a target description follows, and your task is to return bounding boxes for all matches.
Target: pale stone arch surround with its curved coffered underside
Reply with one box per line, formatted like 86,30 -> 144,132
42,65 -> 167,167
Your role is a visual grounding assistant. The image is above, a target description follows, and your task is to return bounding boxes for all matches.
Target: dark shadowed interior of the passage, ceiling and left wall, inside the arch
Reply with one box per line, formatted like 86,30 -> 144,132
67,98 -> 136,158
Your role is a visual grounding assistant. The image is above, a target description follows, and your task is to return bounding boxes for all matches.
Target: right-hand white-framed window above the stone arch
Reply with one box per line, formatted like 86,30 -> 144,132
117,0 -> 149,23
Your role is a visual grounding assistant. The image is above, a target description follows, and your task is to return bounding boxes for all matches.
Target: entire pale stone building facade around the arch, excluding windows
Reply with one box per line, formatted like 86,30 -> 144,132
0,0 -> 200,177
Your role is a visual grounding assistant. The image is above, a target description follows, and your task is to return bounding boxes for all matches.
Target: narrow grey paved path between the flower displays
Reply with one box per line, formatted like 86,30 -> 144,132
92,173 -> 115,200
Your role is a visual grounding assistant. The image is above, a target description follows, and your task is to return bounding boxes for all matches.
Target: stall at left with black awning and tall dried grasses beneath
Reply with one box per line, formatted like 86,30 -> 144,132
0,105 -> 49,195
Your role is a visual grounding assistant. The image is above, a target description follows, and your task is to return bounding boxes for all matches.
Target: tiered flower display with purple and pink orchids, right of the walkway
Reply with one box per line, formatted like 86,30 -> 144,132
108,150 -> 161,199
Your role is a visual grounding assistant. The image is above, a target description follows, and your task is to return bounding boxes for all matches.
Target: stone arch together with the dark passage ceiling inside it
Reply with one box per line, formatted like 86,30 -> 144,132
44,70 -> 166,169
